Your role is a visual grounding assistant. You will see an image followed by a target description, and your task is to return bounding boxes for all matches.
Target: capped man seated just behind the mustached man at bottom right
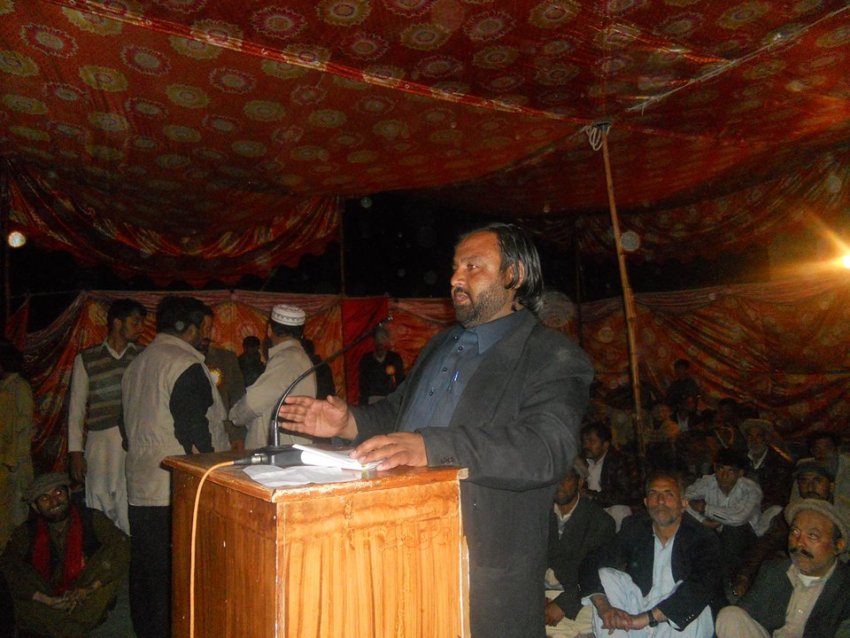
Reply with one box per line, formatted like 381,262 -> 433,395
732,458 -> 833,598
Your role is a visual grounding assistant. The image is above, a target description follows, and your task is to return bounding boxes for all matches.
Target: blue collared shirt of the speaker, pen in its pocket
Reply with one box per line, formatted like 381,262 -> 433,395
399,310 -> 528,432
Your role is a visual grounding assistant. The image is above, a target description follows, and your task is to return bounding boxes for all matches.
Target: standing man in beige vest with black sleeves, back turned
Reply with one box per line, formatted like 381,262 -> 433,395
121,297 -> 228,638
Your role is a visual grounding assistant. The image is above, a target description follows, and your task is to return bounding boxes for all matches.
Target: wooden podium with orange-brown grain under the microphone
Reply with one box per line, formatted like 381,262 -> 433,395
165,453 -> 469,638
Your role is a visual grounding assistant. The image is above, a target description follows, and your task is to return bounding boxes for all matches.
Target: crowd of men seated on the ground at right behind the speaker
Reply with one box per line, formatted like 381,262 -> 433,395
546,366 -> 850,638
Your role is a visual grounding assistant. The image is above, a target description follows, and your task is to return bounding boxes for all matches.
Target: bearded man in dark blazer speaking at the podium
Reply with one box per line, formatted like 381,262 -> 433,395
280,224 -> 593,638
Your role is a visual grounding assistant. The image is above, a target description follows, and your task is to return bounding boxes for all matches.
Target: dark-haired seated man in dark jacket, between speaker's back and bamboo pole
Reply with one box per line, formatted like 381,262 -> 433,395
581,422 -> 637,526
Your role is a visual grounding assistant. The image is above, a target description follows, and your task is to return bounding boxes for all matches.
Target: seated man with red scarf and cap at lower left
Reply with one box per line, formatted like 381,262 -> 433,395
0,473 -> 130,638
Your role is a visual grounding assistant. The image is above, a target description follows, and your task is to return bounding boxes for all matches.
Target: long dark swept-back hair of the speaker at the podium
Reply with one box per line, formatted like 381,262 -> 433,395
460,222 -> 543,314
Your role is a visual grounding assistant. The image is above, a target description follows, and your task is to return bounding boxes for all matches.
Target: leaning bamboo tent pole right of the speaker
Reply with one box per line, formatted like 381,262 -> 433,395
602,125 -> 646,475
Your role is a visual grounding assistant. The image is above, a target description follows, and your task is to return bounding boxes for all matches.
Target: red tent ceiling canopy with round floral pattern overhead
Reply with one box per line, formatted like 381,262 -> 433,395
0,0 -> 850,281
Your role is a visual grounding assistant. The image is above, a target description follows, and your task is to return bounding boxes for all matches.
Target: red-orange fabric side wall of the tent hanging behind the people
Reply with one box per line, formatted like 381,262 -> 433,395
25,277 -> 850,472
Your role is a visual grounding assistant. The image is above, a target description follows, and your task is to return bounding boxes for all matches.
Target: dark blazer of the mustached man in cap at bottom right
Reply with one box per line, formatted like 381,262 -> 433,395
738,558 -> 850,638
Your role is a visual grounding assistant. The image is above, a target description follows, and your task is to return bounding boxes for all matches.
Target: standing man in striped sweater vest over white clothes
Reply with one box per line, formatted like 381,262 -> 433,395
68,299 -> 147,534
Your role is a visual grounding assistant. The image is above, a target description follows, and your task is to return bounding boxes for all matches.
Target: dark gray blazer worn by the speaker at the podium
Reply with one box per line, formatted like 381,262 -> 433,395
354,310 -> 593,638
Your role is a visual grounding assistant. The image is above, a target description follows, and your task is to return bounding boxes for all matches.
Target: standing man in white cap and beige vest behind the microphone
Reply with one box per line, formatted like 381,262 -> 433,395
230,304 -> 316,450
